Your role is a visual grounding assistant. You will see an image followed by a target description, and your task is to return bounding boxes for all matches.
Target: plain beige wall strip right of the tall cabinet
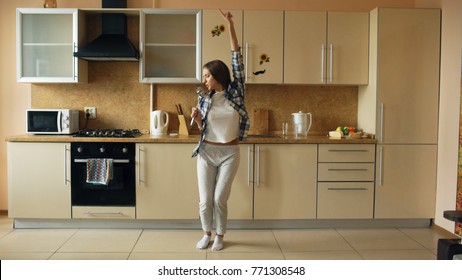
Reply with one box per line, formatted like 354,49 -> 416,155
416,0 -> 462,232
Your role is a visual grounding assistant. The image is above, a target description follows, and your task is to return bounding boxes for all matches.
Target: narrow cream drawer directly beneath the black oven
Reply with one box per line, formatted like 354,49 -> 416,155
72,206 -> 135,219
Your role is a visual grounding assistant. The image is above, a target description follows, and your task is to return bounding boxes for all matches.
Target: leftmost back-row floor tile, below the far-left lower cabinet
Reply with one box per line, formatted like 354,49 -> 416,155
0,229 -> 77,253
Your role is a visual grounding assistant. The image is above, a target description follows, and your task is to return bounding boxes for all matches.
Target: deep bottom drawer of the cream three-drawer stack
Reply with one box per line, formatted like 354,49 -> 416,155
317,183 -> 374,219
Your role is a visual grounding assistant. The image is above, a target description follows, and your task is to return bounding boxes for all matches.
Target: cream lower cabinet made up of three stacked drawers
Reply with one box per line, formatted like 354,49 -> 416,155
317,144 -> 375,219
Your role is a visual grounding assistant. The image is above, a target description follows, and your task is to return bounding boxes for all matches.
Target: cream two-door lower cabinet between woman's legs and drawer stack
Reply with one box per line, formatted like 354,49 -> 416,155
228,144 -> 317,220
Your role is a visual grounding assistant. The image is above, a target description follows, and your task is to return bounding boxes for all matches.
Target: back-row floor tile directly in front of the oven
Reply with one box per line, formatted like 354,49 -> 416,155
58,229 -> 142,253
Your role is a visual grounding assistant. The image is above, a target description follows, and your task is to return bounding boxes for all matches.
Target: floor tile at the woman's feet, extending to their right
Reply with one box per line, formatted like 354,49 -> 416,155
207,230 -> 281,254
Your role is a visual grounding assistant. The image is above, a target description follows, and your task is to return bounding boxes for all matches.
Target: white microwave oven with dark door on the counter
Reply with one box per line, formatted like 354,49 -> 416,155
26,109 -> 79,134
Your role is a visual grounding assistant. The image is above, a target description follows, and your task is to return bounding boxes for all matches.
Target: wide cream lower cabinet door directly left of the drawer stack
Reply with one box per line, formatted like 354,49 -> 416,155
254,144 -> 317,220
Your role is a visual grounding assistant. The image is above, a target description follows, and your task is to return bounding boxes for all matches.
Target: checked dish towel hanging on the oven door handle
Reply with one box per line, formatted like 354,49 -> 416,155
87,158 -> 113,185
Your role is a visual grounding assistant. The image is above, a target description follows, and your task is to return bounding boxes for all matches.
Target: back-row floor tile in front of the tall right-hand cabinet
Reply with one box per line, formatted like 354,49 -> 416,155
337,228 -> 425,251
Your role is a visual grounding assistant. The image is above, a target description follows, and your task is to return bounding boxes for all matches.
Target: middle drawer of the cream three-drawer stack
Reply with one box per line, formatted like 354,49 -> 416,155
318,163 -> 374,182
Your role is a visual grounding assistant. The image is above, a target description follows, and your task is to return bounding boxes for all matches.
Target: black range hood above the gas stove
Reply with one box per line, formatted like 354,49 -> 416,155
74,1 -> 140,61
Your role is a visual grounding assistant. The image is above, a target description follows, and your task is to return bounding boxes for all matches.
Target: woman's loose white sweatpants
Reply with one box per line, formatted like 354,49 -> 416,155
197,143 -> 240,235
